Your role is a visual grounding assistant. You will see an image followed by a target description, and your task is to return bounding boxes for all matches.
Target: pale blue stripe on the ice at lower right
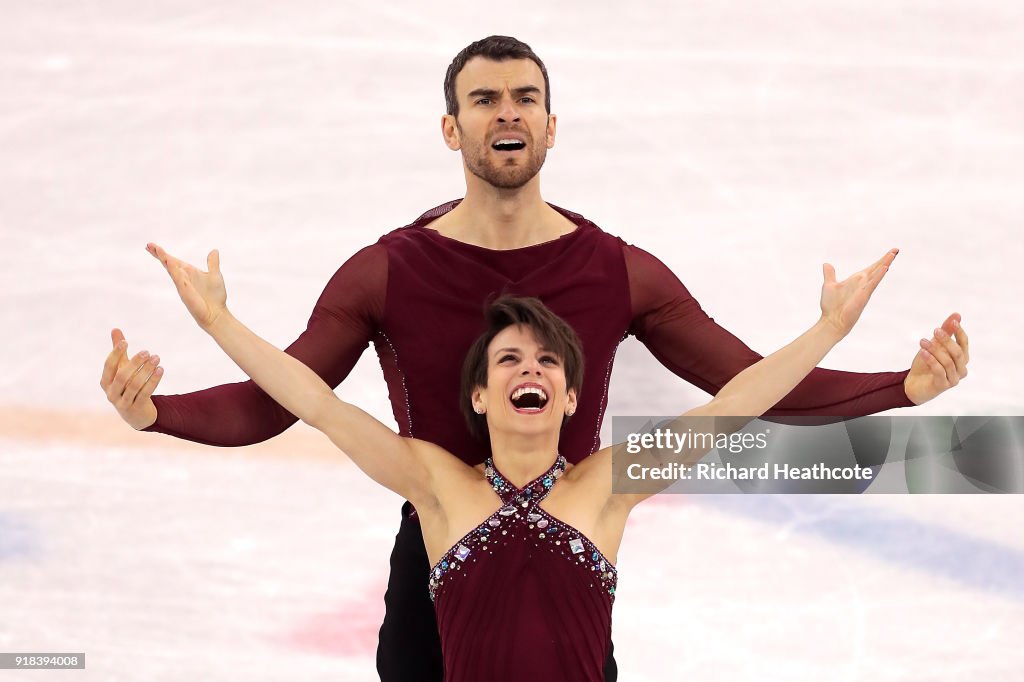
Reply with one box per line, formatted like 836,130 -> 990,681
699,495 -> 1024,600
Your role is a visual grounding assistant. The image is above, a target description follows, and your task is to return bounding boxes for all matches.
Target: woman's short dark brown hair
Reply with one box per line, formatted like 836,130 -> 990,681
460,296 -> 583,440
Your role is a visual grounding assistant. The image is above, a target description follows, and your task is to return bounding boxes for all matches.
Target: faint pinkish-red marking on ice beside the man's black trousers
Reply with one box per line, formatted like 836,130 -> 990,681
284,583 -> 387,656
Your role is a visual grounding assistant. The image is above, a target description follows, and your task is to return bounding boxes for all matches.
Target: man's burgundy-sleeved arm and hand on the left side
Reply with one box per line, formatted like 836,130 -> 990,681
100,245 -> 387,446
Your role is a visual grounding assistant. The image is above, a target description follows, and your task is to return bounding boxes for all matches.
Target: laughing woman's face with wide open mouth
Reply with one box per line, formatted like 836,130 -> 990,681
473,326 -> 577,433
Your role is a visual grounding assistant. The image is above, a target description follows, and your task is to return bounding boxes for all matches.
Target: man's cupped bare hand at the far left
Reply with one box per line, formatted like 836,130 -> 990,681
99,329 -> 164,430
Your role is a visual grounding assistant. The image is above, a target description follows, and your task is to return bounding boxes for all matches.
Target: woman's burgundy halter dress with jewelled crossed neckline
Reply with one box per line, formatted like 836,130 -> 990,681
429,456 -> 616,682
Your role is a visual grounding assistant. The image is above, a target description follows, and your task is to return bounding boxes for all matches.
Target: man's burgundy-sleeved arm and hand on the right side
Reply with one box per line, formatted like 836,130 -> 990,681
624,246 -> 969,417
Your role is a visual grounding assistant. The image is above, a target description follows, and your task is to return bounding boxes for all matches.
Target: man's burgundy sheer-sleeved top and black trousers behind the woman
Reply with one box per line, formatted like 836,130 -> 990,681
150,201 -> 910,680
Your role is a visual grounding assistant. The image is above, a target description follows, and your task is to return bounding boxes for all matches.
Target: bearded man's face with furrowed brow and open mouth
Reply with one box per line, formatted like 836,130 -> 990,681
443,57 -> 555,189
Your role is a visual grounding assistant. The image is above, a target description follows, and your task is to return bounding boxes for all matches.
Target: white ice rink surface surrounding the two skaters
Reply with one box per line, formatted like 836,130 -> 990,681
0,0 -> 1024,682
